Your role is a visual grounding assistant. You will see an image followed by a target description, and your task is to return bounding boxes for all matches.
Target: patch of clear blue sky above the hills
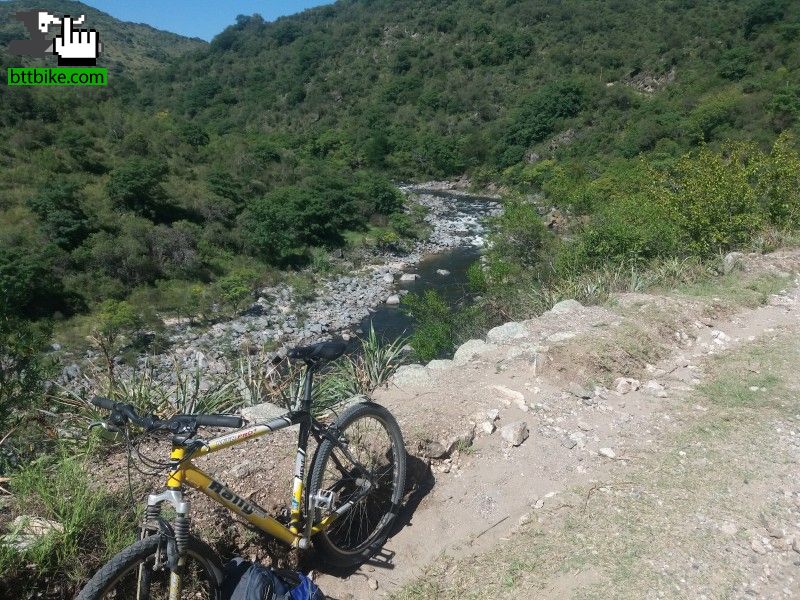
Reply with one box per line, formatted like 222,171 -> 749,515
79,0 -> 332,41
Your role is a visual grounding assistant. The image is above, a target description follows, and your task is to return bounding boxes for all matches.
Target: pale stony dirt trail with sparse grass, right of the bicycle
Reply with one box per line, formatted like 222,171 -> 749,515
319,252 -> 800,600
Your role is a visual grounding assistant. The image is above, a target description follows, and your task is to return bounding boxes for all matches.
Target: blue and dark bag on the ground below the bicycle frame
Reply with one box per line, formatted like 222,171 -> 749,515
222,558 -> 325,600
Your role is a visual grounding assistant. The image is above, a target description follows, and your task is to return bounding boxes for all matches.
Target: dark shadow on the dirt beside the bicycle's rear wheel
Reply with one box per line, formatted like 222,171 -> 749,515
303,453 -> 436,579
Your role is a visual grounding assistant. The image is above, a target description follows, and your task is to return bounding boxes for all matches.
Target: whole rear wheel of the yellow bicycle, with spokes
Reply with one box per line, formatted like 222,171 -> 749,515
309,402 -> 406,567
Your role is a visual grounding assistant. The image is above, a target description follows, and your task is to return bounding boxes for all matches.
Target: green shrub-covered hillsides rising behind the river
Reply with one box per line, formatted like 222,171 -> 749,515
0,0 -> 800,324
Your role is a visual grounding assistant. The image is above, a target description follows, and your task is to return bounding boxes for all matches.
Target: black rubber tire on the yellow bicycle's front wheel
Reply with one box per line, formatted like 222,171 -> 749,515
75,535 -> 222,600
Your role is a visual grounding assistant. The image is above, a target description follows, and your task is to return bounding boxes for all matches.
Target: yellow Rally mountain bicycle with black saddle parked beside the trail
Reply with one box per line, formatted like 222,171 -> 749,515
77,342 -> 406,600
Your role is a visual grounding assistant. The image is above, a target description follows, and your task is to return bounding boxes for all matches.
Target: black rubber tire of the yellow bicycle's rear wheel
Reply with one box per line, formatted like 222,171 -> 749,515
309,402 -> 406,568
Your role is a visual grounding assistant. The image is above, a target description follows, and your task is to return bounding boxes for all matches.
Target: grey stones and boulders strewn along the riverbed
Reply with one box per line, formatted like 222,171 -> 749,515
58,186 -> 500,388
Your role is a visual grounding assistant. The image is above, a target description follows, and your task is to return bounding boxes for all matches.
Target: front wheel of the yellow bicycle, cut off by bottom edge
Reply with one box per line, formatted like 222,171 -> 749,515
75,535 -> 222,600
